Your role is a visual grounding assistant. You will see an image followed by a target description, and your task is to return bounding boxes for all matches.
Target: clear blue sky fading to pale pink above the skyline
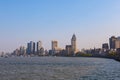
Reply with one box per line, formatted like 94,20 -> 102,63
0,0 -> 120,52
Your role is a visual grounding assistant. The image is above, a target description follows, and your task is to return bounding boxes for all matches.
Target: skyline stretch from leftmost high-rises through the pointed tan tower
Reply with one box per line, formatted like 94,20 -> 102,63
12,34 -> 78,56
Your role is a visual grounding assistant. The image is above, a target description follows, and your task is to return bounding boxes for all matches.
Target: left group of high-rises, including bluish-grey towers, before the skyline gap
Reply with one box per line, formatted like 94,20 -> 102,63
12,41 -> 45,56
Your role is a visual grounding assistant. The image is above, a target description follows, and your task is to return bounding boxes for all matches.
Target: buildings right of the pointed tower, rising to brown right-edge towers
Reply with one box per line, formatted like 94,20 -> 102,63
83,36 -> 120,56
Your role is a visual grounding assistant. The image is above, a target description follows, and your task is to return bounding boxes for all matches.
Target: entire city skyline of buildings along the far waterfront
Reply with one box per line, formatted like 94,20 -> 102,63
2,34 -> 120,56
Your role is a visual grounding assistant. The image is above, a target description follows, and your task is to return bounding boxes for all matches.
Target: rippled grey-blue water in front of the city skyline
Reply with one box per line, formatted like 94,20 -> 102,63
0,57 -> 120,80
